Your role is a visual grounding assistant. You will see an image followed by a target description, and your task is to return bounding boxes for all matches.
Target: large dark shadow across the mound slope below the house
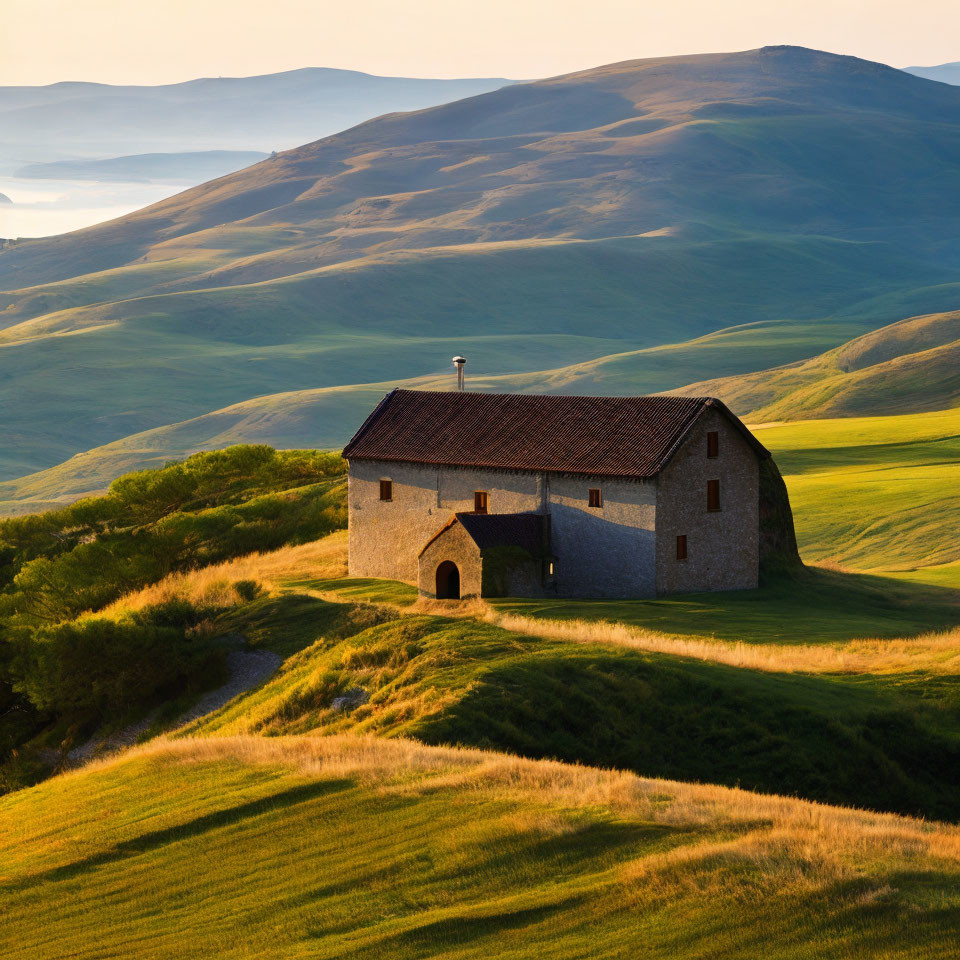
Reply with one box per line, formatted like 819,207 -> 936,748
409,640 -> 960,820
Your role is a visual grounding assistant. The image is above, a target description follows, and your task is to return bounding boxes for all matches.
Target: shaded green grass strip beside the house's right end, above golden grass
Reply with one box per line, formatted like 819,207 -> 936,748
491,567 -> 960,643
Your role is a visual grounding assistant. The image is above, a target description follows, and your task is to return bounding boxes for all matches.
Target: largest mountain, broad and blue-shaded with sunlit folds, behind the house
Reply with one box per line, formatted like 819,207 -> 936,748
0,47 -> 960,477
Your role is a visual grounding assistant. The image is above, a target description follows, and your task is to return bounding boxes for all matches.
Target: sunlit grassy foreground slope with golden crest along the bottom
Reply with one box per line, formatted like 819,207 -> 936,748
0,737 -> 960,960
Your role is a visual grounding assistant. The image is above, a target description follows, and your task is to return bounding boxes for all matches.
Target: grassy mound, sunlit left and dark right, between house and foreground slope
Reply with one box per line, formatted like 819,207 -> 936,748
169,585 -> 960,820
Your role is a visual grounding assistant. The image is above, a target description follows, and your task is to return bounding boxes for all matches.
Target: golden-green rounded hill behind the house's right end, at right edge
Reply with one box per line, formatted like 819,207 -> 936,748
675,311 -> 960,421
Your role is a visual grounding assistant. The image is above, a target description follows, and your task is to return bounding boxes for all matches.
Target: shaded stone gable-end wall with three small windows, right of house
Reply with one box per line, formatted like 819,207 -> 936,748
656,409 -> 759,594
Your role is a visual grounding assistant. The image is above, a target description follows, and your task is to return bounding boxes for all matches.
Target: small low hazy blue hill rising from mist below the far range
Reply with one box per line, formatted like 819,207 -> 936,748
15,150 -> 267,184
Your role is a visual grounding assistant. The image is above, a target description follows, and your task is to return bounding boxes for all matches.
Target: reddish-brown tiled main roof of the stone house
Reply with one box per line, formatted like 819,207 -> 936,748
343,390 -> 769,477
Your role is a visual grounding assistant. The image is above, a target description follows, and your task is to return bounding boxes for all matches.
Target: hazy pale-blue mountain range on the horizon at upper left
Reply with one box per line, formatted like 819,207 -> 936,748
0,67 -> 510,166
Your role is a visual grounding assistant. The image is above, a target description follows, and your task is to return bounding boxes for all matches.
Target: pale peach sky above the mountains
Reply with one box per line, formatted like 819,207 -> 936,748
0,0 -> 960,85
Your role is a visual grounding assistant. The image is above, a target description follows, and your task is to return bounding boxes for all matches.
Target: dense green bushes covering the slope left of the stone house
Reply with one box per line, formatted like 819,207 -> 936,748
0,445 -> 346,780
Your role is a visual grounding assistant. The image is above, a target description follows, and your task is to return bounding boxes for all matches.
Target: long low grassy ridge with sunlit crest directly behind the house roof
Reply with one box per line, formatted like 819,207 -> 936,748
0,320 -> 876,513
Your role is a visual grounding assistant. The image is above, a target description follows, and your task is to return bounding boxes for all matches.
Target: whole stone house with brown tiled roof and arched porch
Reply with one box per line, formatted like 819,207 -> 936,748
343,390 -> 796,598
